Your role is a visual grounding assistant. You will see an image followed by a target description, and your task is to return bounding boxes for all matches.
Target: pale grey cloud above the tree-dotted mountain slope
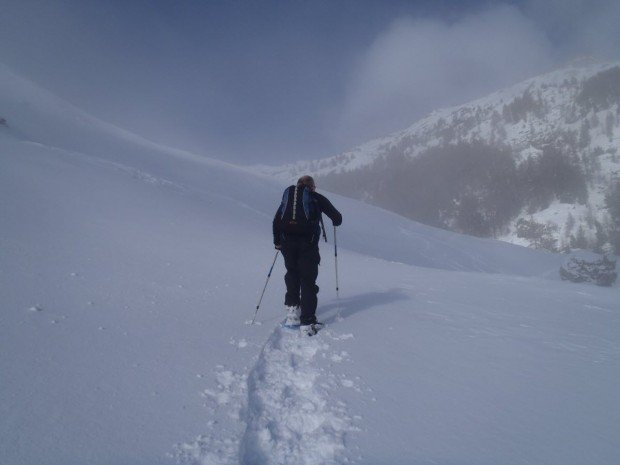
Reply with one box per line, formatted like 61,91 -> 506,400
338,5 -> 553,142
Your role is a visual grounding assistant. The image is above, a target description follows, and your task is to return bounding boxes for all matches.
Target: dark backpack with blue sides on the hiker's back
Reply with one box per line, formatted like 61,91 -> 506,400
280,185 -> 321,237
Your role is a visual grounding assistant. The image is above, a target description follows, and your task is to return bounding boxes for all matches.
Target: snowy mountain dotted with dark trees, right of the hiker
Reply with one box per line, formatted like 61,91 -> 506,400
261,59 -> 620,254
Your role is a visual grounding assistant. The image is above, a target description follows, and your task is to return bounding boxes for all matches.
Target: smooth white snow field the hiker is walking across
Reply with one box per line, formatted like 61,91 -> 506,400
0,62 -> 620,465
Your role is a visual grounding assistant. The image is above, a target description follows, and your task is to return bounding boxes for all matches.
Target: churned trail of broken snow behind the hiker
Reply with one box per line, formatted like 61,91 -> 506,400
240,328 -> 357,465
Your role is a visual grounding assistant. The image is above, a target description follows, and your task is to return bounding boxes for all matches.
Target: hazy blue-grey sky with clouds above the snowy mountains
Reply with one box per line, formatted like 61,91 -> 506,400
0,0 -> 620,164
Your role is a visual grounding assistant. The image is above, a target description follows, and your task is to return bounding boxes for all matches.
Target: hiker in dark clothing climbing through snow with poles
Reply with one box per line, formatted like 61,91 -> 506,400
273,175 -> 342,336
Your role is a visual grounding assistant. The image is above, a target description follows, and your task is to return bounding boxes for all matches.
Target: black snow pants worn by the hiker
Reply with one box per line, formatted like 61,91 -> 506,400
281,236 -> 321,325
